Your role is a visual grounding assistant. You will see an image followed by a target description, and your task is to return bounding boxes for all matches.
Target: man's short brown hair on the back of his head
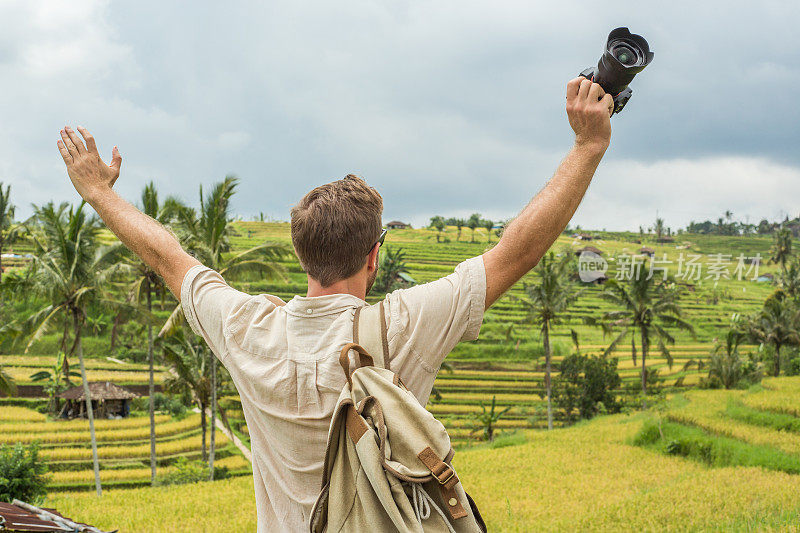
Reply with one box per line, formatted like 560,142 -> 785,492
292,174 -> 383,287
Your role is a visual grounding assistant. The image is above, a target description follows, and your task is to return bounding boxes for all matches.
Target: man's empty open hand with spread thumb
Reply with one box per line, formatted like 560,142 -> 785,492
58,126 -> 122,203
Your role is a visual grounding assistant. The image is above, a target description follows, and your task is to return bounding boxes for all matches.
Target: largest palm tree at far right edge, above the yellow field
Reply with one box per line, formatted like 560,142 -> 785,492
747,290 -> 800,376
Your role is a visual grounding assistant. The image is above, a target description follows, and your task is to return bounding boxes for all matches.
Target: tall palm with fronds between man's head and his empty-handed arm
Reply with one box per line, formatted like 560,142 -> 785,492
159,176 -> 289,476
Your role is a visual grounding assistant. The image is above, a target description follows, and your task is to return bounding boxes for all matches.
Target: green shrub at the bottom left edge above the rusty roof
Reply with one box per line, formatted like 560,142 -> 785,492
0,443 -> 48,504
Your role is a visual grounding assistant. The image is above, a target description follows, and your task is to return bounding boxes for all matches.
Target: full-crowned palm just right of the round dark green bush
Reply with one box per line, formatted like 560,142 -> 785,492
601,275 -> 694,408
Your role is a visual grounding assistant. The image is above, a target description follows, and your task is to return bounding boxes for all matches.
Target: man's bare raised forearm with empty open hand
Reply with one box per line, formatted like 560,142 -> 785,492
58,127 -> 200,300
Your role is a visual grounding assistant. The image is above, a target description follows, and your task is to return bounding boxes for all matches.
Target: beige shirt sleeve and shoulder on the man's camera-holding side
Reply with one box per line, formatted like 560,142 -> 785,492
386,256 -> 486,405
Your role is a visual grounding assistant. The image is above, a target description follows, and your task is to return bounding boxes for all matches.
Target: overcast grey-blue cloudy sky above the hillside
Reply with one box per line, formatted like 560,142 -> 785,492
0,0 -> 800,230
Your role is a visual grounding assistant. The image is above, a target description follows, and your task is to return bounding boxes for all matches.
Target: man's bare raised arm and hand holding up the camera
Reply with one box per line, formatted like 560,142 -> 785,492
483,78 -> 614,309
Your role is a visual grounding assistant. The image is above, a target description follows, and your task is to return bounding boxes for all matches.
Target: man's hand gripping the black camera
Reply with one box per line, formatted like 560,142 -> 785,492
567,77 -> 614,149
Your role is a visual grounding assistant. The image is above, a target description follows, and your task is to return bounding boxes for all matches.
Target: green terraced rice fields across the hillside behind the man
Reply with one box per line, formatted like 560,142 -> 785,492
0,222 -> 797,489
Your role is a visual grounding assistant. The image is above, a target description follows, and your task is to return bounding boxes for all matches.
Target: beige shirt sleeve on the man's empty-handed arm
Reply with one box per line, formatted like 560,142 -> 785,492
181,265 -> 254,360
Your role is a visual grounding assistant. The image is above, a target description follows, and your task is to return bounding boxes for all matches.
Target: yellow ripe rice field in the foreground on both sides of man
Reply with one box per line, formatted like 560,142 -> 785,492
48,377 -> 800,532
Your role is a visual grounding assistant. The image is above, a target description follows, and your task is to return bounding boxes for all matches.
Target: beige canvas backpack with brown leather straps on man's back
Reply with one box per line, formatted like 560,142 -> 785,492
310,302 -> 486,533
